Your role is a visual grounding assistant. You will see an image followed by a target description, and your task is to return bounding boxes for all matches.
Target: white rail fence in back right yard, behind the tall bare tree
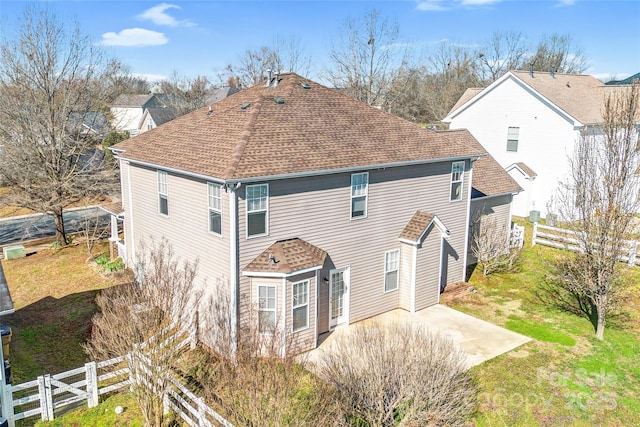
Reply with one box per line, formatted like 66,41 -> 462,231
531,222 -> 640,265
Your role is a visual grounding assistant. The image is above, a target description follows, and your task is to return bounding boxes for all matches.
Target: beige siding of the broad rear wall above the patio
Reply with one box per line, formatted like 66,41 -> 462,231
238,162 -> 470,333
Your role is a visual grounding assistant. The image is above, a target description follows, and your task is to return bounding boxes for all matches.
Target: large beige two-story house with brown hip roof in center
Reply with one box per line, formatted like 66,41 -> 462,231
113,74 -> 519,352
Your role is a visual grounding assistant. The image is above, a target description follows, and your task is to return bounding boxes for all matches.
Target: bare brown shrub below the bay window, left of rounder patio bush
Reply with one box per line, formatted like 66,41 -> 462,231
198,292 -> 341,427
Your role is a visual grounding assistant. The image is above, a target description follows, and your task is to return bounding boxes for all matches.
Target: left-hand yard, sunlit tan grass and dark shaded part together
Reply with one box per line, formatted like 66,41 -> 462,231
2,243 -> 129,384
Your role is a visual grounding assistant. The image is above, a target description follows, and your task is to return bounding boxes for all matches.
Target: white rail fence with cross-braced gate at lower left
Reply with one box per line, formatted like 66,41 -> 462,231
3,338 -> 233,427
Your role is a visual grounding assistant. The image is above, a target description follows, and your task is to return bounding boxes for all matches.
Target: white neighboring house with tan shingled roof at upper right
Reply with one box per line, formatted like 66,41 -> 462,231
443,71 -> 636,221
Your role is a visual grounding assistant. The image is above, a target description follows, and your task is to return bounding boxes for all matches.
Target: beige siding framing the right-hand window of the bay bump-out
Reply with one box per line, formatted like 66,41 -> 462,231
284,271 -> 322,354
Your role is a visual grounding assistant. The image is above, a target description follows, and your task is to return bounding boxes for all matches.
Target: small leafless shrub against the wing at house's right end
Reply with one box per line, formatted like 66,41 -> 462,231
470,212 -> 522,277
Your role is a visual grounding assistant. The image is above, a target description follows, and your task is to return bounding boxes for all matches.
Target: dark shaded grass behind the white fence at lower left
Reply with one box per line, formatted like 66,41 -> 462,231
2,290 -> 100,384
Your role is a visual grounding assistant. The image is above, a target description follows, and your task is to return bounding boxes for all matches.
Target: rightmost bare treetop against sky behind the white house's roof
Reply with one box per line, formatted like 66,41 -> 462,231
528,33 -> 587,74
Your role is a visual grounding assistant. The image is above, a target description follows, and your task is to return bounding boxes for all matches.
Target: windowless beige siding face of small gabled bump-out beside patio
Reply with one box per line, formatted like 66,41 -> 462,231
416,231 -> 445,311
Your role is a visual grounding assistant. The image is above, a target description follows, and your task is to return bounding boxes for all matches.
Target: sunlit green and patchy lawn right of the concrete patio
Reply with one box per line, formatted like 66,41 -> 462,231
450,221 -> 640,426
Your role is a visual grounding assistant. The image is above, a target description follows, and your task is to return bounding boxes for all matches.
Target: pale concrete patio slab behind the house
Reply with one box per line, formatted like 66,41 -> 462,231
307,304 -> 531,368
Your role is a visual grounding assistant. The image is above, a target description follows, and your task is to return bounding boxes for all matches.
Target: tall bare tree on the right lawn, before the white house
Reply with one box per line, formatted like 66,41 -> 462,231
554,84 -> 640,339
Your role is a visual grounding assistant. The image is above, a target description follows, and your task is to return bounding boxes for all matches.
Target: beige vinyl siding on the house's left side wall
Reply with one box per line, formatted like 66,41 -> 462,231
122,165 -> 231,318
